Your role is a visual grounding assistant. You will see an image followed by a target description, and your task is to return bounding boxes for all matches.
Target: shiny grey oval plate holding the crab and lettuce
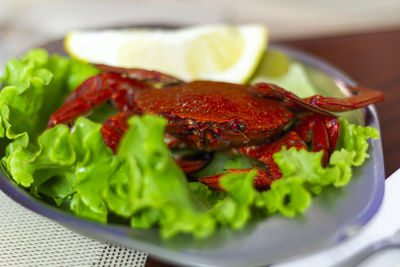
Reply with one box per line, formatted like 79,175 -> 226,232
0,41 -> 385,266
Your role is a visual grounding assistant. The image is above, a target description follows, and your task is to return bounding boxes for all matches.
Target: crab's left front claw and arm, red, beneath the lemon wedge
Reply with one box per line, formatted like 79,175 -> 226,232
47,67 -> 184,128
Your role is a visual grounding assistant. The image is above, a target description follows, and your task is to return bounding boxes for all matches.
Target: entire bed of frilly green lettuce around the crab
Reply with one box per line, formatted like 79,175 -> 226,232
0,27 -> 379,241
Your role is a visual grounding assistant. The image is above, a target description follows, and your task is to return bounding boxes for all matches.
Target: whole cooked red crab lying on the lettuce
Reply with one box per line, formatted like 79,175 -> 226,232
48,65 -> 383,190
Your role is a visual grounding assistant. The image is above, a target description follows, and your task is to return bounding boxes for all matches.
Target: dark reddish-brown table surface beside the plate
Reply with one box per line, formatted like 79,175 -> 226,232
146,29 -> 400,267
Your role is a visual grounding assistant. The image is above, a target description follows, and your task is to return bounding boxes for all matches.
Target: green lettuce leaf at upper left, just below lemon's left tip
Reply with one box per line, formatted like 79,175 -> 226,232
0,49 -> 98,147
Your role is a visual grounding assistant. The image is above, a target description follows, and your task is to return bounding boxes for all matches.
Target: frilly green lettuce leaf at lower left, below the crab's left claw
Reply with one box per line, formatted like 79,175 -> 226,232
3,118 -> 120,222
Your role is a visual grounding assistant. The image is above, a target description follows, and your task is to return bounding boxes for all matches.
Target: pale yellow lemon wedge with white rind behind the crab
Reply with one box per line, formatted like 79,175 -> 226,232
64,24 -> 267,83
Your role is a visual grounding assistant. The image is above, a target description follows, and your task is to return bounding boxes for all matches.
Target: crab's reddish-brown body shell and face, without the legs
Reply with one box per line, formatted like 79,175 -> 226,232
137,81 -> 294,150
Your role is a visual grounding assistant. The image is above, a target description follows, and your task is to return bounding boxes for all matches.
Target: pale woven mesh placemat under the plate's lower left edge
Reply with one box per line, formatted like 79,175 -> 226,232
0,191 -> 147,267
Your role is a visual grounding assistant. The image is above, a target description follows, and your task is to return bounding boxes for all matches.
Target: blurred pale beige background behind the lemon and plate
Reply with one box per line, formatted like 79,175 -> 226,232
0,0 -> 400,63
